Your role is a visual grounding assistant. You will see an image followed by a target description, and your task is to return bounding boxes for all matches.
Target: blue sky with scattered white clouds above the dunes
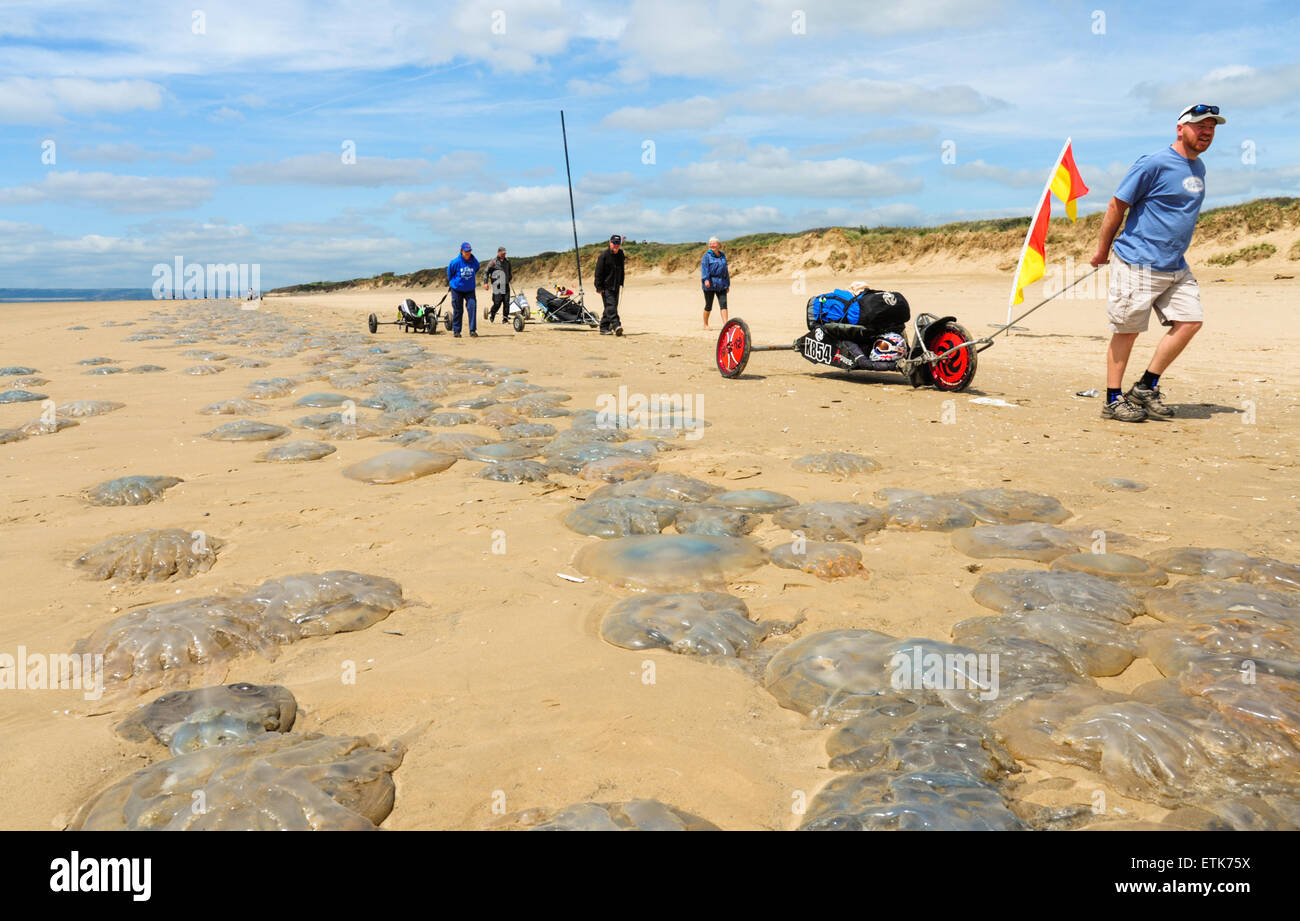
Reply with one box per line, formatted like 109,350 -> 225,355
0,0 -> 1300,287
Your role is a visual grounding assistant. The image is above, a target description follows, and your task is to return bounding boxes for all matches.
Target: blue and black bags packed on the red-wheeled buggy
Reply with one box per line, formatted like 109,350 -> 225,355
807,282 -> 911,371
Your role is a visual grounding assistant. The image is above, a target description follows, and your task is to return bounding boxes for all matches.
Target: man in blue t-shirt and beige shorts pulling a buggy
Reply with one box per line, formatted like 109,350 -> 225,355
1091,105 -> 1227,421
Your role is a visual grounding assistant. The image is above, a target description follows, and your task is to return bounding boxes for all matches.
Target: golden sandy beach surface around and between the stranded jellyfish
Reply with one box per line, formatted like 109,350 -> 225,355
0,264 -> 1300,830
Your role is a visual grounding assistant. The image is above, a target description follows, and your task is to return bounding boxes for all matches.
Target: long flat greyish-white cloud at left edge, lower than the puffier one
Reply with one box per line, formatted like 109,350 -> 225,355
0,172 -> 216,213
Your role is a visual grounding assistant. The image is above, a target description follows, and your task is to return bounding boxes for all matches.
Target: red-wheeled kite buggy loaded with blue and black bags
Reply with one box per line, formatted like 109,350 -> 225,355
716,285 -> 993,392
